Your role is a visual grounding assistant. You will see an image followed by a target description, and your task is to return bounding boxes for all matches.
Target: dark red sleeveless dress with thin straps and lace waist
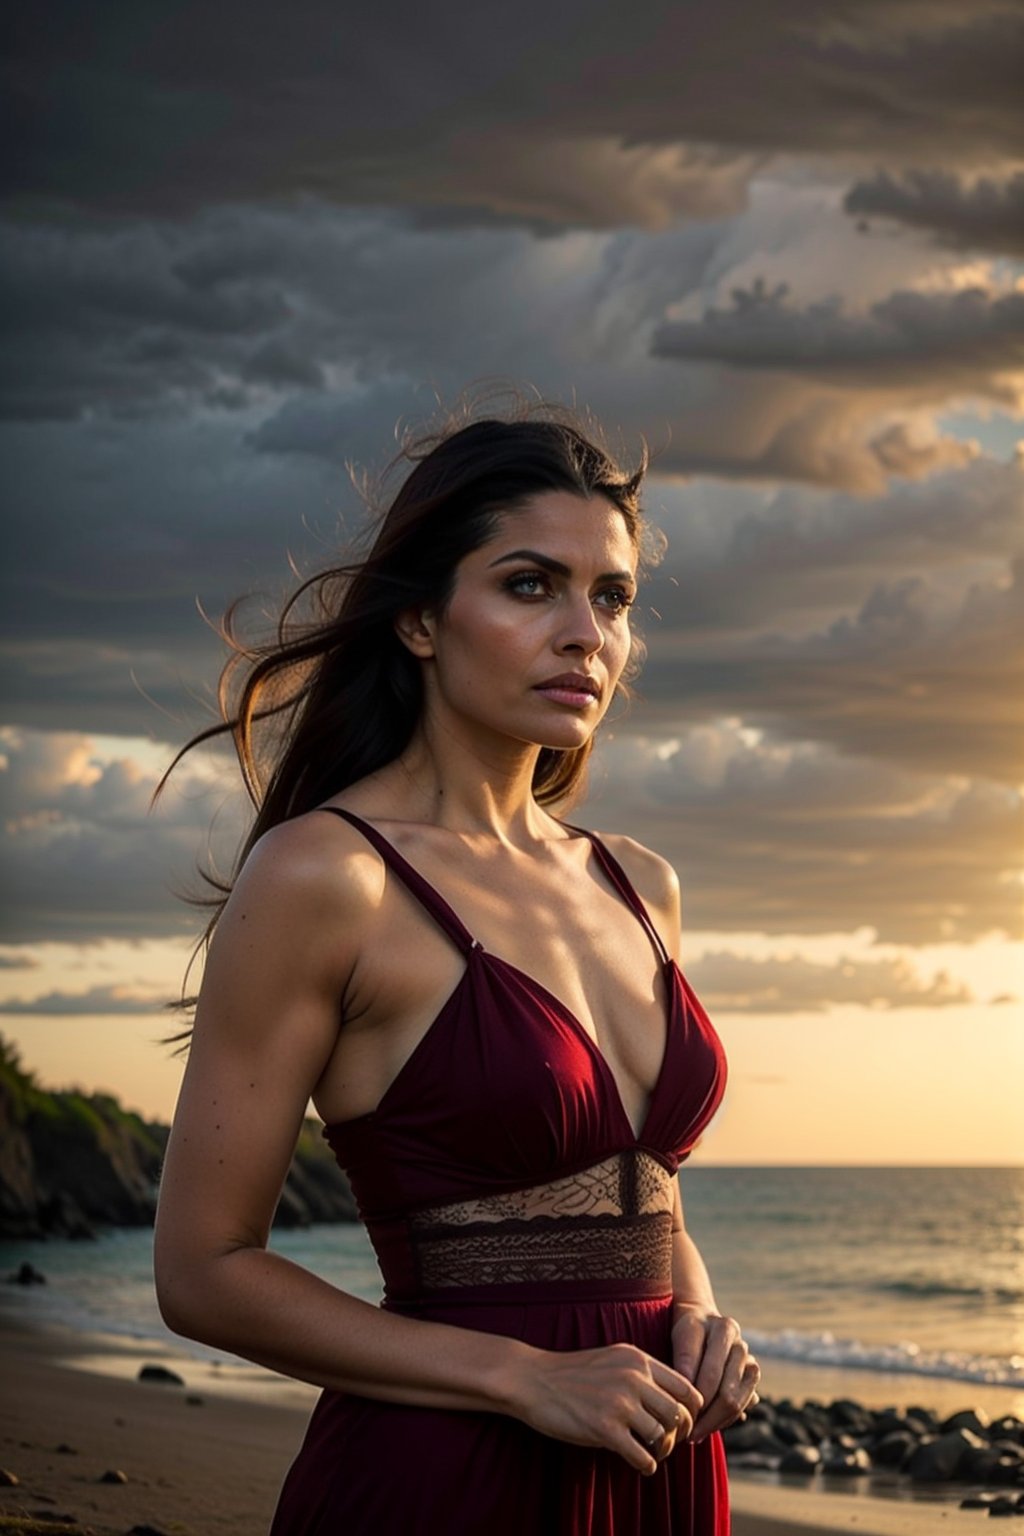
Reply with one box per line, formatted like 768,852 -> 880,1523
272,811 -> 729,1536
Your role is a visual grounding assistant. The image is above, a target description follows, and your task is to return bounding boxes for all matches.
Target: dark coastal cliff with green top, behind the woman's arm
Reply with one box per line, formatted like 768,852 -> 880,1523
0,1037 -> 356,1238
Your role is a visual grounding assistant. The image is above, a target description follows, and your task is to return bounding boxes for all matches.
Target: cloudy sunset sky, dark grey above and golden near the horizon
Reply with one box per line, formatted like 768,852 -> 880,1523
0,0 -> 1024,1163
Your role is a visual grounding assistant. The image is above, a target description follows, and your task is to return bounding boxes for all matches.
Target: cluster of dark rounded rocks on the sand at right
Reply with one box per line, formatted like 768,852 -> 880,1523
723,1398 -> 1024,1514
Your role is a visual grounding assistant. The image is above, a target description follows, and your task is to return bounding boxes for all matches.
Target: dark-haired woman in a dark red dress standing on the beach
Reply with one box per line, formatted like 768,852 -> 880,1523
157,410 -> 758,1536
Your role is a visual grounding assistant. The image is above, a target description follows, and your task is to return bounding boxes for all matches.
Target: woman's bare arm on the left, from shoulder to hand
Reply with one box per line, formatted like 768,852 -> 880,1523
155,819 -> 700,1471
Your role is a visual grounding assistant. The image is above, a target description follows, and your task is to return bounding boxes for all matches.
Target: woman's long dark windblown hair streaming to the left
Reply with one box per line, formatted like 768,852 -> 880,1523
157,390 -> 646,976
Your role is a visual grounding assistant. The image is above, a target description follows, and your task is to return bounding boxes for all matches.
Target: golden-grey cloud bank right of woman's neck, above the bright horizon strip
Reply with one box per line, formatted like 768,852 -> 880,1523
574,722 -> 1024,945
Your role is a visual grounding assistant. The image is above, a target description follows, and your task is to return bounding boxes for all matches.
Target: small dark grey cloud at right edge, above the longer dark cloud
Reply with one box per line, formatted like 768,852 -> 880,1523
843,170 -> 1024,257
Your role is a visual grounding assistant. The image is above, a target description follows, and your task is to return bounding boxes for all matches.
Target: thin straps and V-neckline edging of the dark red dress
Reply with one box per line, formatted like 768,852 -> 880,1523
319,805 -> 683,1146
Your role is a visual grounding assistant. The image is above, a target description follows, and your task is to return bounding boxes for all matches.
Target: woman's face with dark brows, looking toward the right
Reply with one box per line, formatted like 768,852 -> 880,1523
407,492 -> 637,750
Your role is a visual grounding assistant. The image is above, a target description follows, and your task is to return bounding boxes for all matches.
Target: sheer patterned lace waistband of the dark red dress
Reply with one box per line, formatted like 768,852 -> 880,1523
370,1149 -> 674,1306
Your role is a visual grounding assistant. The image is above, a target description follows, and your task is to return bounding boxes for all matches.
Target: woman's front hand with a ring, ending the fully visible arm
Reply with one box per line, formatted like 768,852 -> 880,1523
511,1344 -> 703,1475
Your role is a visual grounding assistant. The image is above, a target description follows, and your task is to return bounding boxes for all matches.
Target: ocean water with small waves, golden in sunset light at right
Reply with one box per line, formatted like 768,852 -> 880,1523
0,1166 -> 1024,1412
